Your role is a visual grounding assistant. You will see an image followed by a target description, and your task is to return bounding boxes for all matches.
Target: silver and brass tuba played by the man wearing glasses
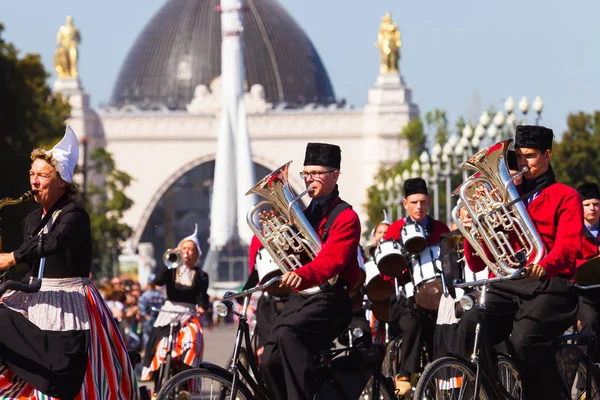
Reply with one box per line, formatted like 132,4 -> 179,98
246,161 -> 337,295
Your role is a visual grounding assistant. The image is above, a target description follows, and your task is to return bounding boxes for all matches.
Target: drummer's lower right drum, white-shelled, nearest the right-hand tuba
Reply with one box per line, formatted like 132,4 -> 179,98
405,246 -> 444,310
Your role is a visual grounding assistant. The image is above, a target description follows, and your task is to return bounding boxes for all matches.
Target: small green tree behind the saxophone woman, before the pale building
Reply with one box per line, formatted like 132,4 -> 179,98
86,147 -> 133,277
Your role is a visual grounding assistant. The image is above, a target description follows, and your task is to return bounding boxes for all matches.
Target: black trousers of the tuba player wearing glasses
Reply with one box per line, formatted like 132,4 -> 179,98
261,290 -> 352,400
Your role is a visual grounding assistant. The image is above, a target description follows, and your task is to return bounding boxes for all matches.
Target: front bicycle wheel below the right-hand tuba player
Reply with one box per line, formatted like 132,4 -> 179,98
414,357 -> 490,400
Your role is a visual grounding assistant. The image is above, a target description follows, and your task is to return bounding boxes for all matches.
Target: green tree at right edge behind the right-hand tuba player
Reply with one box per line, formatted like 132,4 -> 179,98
552,111 -> 600,187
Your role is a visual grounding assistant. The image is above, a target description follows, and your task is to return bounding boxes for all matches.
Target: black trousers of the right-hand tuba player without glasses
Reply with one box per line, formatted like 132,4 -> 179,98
459,277 -> 577,400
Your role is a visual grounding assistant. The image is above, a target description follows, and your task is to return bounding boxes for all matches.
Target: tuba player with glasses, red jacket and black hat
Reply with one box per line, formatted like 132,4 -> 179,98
261,143 -> 360,399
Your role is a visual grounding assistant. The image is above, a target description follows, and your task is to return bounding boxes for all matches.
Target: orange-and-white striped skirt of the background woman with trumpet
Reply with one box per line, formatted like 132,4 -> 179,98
141,302 -> 204,381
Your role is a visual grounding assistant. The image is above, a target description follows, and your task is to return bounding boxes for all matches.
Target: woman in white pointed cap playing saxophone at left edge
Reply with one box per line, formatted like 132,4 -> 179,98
0,126 -> 139,400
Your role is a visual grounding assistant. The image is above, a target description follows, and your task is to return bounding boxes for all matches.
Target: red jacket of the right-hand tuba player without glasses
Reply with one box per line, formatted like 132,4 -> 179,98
465,183 -> 583,278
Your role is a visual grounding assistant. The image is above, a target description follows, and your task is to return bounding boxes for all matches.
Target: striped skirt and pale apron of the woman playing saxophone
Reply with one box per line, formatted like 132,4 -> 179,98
0,278 -> 139,400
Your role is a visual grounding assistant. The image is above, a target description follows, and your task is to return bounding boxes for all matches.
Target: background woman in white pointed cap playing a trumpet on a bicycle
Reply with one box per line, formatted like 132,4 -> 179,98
141,225 -> 209,381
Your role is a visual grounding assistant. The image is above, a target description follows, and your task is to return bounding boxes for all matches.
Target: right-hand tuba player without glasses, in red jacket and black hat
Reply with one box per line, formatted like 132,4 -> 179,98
459,125 -> 583,400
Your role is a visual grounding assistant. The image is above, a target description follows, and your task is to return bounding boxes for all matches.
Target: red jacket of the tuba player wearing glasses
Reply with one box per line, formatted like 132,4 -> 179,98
295,198 -> 360,290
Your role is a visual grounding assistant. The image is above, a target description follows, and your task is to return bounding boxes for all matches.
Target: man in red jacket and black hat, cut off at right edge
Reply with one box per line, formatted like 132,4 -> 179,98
577,183 -> 600,363
